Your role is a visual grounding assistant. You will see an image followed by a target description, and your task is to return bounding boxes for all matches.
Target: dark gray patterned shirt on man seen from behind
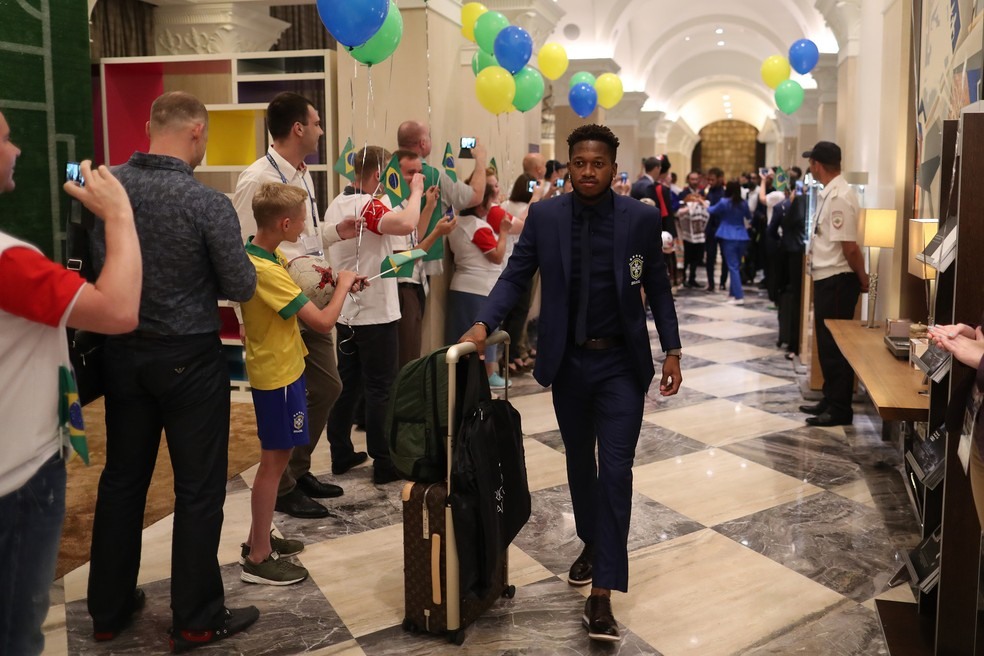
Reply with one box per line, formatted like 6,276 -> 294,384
93,152 -> 256,335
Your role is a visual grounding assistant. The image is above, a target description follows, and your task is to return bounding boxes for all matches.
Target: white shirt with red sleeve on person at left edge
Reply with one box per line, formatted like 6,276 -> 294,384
0,232 -> 85,496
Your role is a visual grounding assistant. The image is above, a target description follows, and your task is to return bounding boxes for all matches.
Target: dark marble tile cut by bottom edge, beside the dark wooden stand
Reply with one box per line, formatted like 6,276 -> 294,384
735,600 -> 888,656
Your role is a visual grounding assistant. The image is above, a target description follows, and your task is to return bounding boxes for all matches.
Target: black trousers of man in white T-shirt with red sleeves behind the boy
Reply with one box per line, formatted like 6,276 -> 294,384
328,321 -> 400,466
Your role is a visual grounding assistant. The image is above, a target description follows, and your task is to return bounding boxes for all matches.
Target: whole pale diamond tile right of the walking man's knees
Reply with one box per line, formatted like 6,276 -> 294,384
633,449 -> 822,526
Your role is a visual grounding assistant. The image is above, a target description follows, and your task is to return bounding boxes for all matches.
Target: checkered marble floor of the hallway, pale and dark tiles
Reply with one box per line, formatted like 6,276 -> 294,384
46,278 -> 918,656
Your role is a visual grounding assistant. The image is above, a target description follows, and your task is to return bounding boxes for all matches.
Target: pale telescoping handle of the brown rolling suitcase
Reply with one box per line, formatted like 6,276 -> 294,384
444,330 -> 509,632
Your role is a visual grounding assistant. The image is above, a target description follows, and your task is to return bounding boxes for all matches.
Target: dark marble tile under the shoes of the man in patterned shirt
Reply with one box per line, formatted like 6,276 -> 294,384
65,565 -> 352,656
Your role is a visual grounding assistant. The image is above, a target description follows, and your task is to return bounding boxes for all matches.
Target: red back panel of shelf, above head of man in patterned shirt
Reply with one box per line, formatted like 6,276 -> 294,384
103,63 -> 164,165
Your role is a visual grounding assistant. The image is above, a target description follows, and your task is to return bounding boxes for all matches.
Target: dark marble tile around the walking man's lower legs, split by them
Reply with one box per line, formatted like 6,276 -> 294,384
513,485 -> 704,580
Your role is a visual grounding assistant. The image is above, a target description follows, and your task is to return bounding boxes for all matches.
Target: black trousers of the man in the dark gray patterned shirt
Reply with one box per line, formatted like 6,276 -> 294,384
88,333 -> 229,630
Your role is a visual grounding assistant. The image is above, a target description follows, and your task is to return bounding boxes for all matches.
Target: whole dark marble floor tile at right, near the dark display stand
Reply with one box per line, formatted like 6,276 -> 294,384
714,492 -> 916,602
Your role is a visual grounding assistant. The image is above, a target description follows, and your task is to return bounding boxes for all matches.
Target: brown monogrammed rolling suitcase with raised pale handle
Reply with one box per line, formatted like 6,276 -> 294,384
402,331 -> 516,645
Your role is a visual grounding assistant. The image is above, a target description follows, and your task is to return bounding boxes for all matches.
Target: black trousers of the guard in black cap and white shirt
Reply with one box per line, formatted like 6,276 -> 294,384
813,272 -> 861,417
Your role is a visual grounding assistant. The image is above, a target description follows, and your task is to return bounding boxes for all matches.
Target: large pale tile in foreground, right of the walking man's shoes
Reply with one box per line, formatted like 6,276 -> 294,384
613,530 -> 844,656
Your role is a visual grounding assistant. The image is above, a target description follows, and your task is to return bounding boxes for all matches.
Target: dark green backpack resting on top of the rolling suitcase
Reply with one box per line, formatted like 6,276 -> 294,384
385,346 -> 460,483
